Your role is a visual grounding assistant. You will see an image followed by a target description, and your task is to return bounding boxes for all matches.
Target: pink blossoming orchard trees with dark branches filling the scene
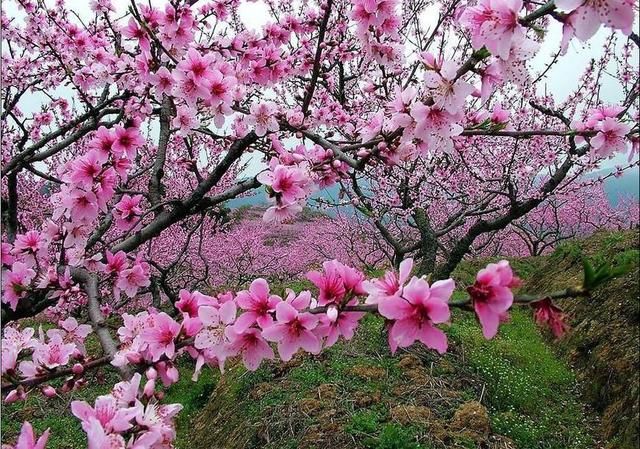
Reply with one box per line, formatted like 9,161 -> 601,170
1,0 -> 640,449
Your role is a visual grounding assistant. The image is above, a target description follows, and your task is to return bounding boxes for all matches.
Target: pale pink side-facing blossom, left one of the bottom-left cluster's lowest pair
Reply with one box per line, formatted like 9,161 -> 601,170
71,395 -> 139,433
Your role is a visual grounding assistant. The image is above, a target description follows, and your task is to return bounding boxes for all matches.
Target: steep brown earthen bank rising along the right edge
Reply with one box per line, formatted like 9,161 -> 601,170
526,231 -> 640,449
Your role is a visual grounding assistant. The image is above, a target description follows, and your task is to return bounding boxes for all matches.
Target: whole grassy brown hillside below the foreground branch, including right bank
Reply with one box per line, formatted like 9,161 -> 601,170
183,232 -> 640,449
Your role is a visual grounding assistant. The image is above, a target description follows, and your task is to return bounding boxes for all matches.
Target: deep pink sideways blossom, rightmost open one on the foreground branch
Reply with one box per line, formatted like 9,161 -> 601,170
467,260 -> 520,339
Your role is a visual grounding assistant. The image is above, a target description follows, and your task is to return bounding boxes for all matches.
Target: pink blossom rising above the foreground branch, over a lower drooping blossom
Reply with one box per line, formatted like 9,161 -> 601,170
234,278 -> 282,333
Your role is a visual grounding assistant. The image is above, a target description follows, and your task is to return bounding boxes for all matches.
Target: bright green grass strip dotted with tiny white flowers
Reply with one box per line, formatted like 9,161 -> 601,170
449,310 -> 593,449
